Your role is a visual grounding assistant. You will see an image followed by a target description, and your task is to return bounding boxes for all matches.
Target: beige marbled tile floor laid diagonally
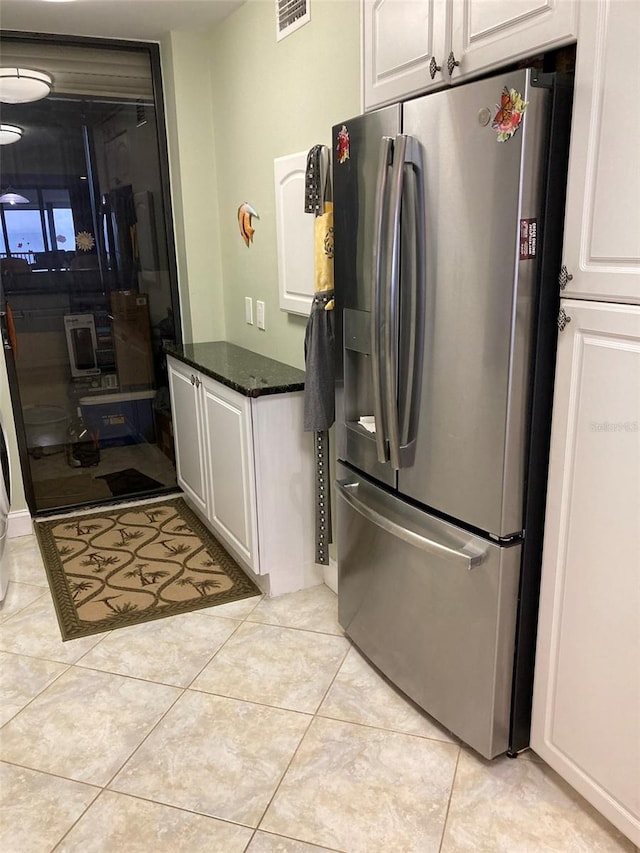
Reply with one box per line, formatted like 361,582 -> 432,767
0,536 -> 635,853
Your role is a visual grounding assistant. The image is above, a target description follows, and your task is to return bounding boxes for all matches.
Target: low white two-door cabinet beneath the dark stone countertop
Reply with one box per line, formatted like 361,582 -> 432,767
167,357 -> 323,595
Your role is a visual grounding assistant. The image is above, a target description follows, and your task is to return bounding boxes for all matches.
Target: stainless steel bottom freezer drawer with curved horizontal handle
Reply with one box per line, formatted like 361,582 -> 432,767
336,466 -> 521,758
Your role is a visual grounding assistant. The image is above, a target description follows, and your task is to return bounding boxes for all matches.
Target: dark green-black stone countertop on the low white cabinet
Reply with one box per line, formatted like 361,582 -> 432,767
165,341 -> 304,397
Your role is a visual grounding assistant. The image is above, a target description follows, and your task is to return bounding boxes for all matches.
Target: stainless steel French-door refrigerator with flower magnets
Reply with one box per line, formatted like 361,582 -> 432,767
333,69 -> 571,758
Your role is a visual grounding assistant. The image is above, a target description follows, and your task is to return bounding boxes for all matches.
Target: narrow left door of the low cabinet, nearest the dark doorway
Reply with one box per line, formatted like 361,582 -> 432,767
167,358 -> 207,515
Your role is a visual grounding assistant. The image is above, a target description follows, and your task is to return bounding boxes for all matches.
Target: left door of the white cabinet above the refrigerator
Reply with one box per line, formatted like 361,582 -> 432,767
362,0 -> 448,110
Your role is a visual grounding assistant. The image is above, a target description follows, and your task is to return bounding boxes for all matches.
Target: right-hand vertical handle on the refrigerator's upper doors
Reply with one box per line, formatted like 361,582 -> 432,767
382,133 -> 422,470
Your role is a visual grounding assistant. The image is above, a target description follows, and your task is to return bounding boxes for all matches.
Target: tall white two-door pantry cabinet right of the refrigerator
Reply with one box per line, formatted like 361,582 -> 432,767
531,0 -> 640,845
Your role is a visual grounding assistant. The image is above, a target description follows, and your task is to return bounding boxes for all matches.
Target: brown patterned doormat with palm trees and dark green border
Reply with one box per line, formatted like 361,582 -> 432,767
35,498 -> 261,640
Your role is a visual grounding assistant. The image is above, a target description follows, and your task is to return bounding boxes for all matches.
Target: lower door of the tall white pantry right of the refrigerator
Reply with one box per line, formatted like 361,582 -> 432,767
531,300 -> 640,844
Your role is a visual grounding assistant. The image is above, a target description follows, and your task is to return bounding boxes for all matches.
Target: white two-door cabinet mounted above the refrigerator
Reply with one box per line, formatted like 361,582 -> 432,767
362,0 -> 578,110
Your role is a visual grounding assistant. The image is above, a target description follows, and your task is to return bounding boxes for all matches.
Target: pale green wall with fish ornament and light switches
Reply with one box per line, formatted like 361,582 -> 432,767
179,0 -> 360,367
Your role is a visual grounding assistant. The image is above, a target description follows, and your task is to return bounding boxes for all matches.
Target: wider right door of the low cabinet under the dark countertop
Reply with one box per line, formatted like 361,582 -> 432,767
202,377 -> 260,573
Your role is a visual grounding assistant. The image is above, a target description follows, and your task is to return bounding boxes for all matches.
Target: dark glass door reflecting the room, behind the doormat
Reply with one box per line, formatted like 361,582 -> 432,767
0,34 -> 180,514
